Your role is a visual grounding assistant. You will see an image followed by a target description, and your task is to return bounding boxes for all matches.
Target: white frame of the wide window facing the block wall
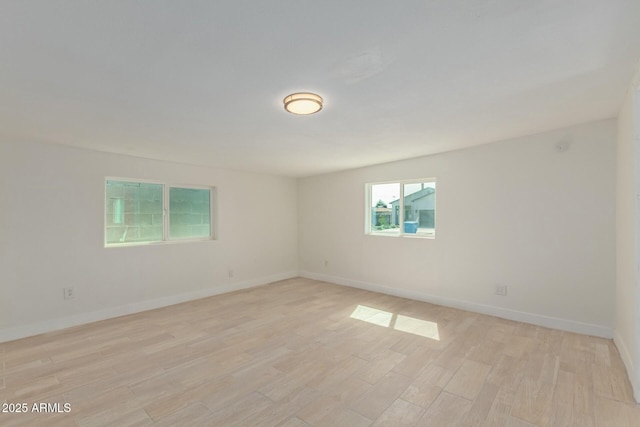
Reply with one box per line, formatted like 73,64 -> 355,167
103,176 -> 218,248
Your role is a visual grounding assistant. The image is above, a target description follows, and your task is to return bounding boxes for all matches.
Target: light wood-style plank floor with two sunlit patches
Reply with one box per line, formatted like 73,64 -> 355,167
0,279 -> 640,427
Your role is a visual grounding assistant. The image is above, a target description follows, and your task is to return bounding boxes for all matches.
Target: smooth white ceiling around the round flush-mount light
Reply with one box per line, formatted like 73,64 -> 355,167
0,0 -> 640,176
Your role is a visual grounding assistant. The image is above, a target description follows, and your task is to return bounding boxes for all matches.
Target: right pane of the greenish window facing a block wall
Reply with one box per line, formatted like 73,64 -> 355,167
169,187 -> 211,239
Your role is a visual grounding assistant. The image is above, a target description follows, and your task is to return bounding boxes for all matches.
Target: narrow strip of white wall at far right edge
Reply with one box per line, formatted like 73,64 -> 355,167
614,61 -> 640,402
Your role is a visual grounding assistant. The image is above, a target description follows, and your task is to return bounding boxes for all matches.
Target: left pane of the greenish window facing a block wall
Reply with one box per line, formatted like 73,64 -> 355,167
105,180 -> 163,245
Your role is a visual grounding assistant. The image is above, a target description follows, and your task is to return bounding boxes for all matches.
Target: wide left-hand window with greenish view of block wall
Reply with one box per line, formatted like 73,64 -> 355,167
105,179 -> 214,246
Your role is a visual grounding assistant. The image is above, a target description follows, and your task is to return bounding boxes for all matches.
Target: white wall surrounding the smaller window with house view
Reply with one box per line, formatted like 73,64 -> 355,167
298,120 -> 616,337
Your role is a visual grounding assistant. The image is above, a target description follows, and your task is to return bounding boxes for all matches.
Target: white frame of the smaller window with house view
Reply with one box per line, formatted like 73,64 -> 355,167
364,177 -> 437,239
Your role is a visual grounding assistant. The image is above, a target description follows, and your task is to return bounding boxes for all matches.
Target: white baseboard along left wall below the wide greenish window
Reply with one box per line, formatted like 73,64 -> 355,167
0,271 -> 298,343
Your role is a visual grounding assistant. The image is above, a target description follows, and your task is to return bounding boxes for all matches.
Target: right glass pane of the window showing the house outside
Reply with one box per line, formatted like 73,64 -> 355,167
404,182 -> 436,234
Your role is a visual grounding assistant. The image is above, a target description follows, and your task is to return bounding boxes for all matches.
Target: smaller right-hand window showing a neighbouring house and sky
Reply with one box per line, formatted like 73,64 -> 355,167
366,179 -> 436,237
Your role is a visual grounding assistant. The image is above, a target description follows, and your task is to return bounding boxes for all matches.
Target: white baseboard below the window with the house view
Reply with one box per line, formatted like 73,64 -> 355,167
300,271 -> 613,339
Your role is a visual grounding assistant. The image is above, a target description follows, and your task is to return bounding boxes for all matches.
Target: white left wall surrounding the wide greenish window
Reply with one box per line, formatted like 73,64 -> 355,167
0,142 -> 298,342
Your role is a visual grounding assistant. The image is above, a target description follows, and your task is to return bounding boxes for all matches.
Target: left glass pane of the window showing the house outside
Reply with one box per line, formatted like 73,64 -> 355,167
371,182 -> 400,235
